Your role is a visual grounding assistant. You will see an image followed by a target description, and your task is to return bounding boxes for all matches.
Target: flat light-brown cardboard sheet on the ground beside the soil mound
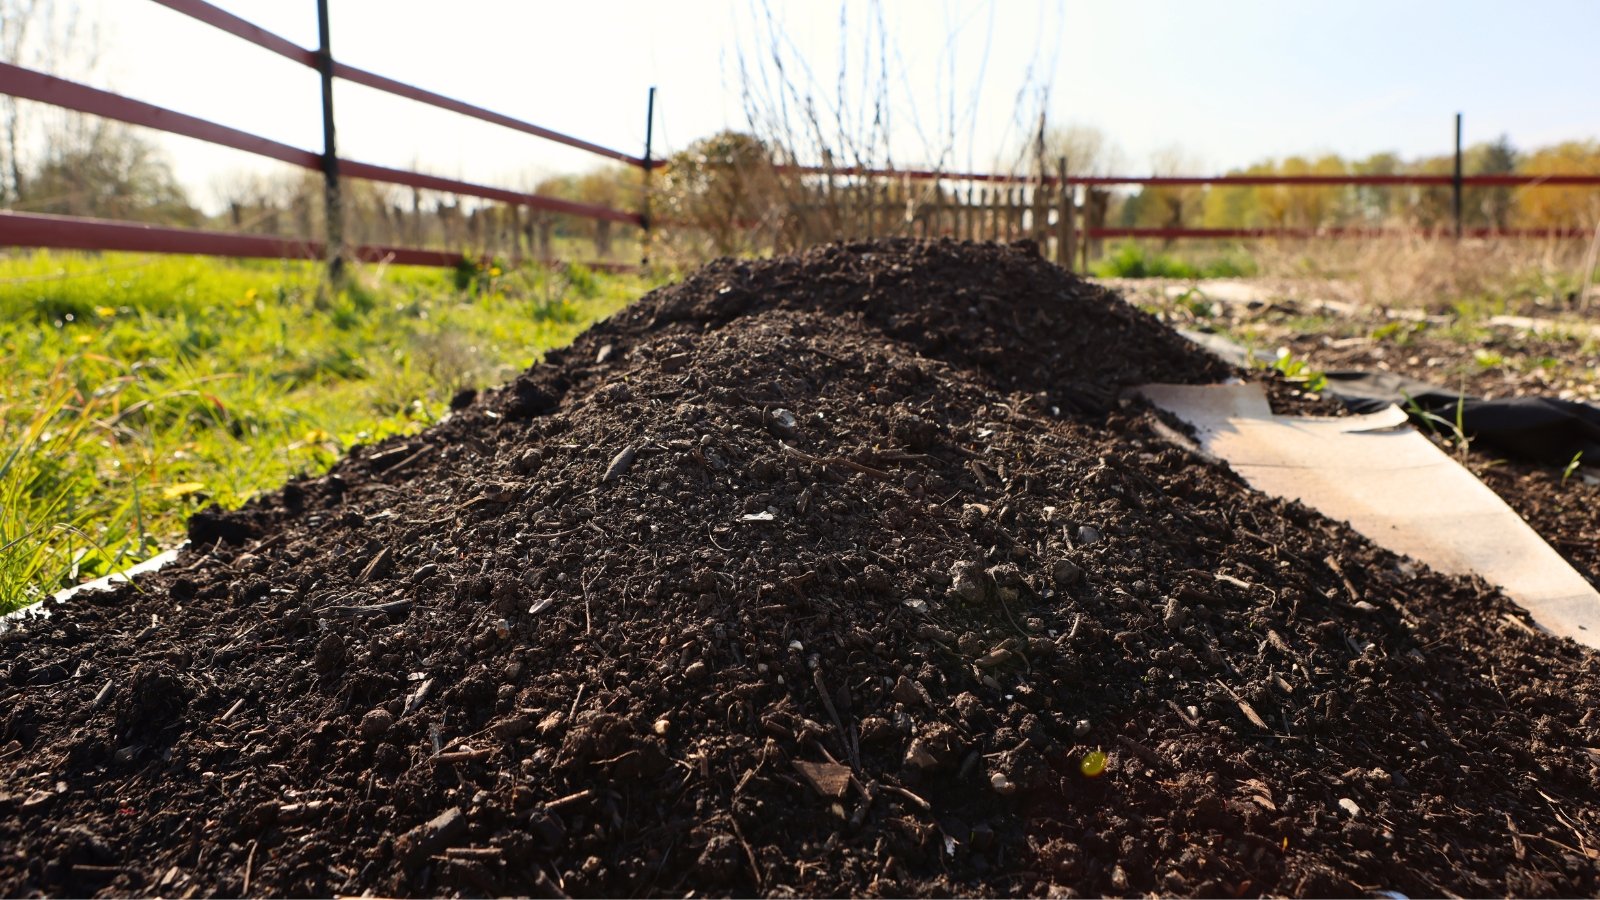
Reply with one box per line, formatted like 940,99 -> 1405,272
1139,384 -> 1600,649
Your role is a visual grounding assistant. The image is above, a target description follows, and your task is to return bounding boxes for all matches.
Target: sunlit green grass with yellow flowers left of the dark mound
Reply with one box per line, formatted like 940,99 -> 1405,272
0,253 -> 653,612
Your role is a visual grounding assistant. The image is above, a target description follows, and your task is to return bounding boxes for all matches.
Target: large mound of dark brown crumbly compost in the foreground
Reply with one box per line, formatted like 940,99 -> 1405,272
0,242 -> 1600,895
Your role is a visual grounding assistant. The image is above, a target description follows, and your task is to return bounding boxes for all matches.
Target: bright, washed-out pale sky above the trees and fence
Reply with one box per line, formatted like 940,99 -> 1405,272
58,0 -> 1600,211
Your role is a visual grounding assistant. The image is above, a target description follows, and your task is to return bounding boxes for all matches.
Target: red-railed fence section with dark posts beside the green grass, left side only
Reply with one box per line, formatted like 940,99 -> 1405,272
0,0 -> 659,275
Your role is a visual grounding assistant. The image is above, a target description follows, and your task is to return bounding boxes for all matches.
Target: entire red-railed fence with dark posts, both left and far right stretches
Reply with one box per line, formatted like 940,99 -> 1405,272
0,0 -> 1600,269
